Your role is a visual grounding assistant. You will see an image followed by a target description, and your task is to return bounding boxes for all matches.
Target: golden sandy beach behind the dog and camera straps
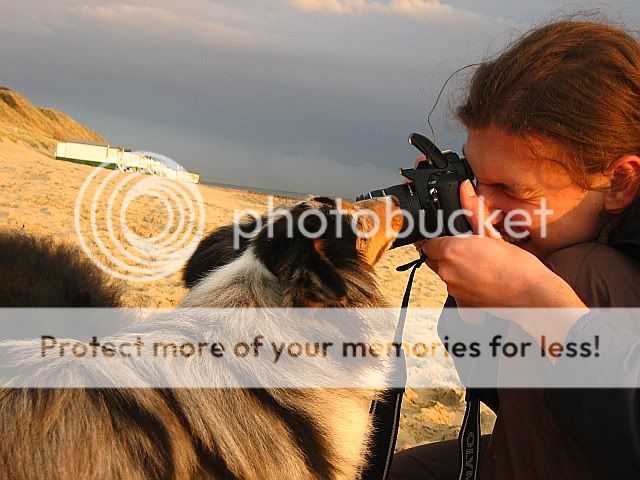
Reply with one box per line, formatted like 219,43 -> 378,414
0,139 -> 493,449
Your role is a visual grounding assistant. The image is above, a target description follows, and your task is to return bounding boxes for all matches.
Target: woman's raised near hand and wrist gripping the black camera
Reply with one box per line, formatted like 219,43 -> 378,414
420,180 -> 588,346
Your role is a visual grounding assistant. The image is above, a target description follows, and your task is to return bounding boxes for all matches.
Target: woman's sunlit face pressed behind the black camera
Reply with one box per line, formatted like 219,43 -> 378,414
465,128 -> 604,258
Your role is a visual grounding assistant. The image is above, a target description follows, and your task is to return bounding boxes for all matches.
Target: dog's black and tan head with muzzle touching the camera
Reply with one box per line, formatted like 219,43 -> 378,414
183,197 -> 403,307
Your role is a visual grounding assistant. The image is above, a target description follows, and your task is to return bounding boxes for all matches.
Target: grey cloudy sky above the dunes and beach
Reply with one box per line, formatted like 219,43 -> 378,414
0,0 -> 640,197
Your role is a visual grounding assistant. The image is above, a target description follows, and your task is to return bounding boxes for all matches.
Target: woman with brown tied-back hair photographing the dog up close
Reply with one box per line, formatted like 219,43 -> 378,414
391,20 -> 640,479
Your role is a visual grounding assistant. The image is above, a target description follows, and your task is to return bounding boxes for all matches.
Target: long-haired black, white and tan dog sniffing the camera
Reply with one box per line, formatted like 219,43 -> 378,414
0,197 -> 402,480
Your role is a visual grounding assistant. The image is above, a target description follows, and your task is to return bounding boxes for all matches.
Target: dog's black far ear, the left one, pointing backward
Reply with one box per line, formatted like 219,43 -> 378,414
182,219 -> 256,288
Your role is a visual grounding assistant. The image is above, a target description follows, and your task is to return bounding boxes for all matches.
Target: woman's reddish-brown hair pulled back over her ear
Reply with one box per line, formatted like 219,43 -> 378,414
456,19 -> 640,192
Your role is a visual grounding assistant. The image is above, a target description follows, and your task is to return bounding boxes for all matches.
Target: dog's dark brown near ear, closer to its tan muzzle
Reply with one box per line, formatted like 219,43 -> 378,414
254,212 -> 347,307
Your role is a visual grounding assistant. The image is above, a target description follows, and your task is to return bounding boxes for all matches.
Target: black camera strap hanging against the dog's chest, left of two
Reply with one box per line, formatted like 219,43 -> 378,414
360,254 -> 427,480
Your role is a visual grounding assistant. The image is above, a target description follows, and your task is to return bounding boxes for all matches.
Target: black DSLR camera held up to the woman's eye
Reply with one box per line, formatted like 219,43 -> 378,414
356,133 -> 475,248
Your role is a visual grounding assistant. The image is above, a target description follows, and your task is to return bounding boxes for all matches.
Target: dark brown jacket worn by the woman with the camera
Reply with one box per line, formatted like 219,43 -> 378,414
438,209 -> 640,480
